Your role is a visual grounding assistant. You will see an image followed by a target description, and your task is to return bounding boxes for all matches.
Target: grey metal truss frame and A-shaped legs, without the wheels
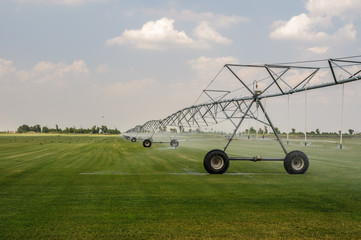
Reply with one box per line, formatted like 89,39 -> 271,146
127,56 -> 361,173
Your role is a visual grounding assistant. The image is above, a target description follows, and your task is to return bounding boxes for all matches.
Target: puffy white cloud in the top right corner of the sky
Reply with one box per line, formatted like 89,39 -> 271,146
269,0 -> 361,42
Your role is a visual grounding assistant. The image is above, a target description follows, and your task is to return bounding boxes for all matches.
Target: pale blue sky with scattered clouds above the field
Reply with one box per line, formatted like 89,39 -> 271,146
0,0 -> 361,131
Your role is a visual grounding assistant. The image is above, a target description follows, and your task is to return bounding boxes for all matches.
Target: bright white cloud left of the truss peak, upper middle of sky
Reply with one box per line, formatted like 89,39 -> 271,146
106,17 -> 232,50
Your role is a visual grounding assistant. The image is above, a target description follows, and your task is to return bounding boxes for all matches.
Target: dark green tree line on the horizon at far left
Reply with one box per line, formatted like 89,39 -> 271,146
17,124 -> 120,134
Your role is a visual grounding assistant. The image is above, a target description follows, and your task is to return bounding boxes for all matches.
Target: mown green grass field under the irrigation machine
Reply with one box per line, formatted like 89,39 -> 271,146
0,135 -> 361,239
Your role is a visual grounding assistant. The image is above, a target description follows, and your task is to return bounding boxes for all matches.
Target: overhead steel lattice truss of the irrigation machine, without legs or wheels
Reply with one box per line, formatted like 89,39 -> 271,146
127,56 -> 361,133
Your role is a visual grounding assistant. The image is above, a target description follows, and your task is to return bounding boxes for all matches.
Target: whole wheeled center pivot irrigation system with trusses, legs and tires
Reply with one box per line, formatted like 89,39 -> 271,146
125,56 -> 361,174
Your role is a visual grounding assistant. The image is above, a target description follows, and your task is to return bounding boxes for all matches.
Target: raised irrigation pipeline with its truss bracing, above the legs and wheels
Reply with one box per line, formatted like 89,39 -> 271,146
127,55 -> 361,132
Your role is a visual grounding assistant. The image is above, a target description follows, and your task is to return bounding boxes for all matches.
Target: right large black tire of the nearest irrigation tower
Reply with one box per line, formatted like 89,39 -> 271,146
283,151 -> 309,174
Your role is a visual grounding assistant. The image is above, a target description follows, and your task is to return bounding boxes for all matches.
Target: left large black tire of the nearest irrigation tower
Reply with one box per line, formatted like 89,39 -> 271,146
203,149 -> 229,174
